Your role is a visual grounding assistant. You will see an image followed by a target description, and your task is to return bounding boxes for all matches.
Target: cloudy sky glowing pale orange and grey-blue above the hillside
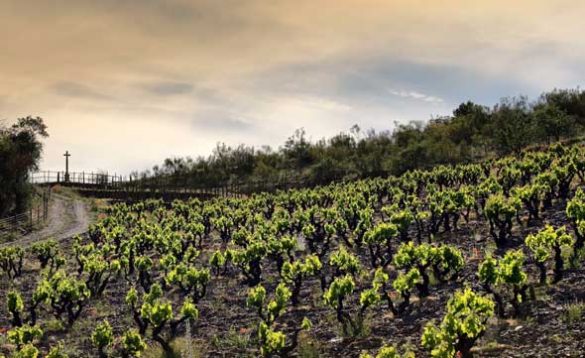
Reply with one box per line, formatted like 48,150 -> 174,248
0,0 -> 585,174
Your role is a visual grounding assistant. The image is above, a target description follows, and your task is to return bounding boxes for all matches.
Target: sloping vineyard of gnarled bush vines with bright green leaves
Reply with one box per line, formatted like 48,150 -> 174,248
0,144 -> 585,358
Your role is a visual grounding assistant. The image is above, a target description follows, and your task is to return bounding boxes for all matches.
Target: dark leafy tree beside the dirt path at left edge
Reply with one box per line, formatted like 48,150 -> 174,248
0,117 -> 48,218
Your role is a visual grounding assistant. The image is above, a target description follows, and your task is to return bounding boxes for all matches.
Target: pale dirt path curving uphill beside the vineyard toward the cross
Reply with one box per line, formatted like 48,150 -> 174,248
0,193 -> 90,247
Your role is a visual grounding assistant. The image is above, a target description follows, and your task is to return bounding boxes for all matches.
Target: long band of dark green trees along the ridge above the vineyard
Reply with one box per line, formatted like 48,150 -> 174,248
140,89 -> 585,189
